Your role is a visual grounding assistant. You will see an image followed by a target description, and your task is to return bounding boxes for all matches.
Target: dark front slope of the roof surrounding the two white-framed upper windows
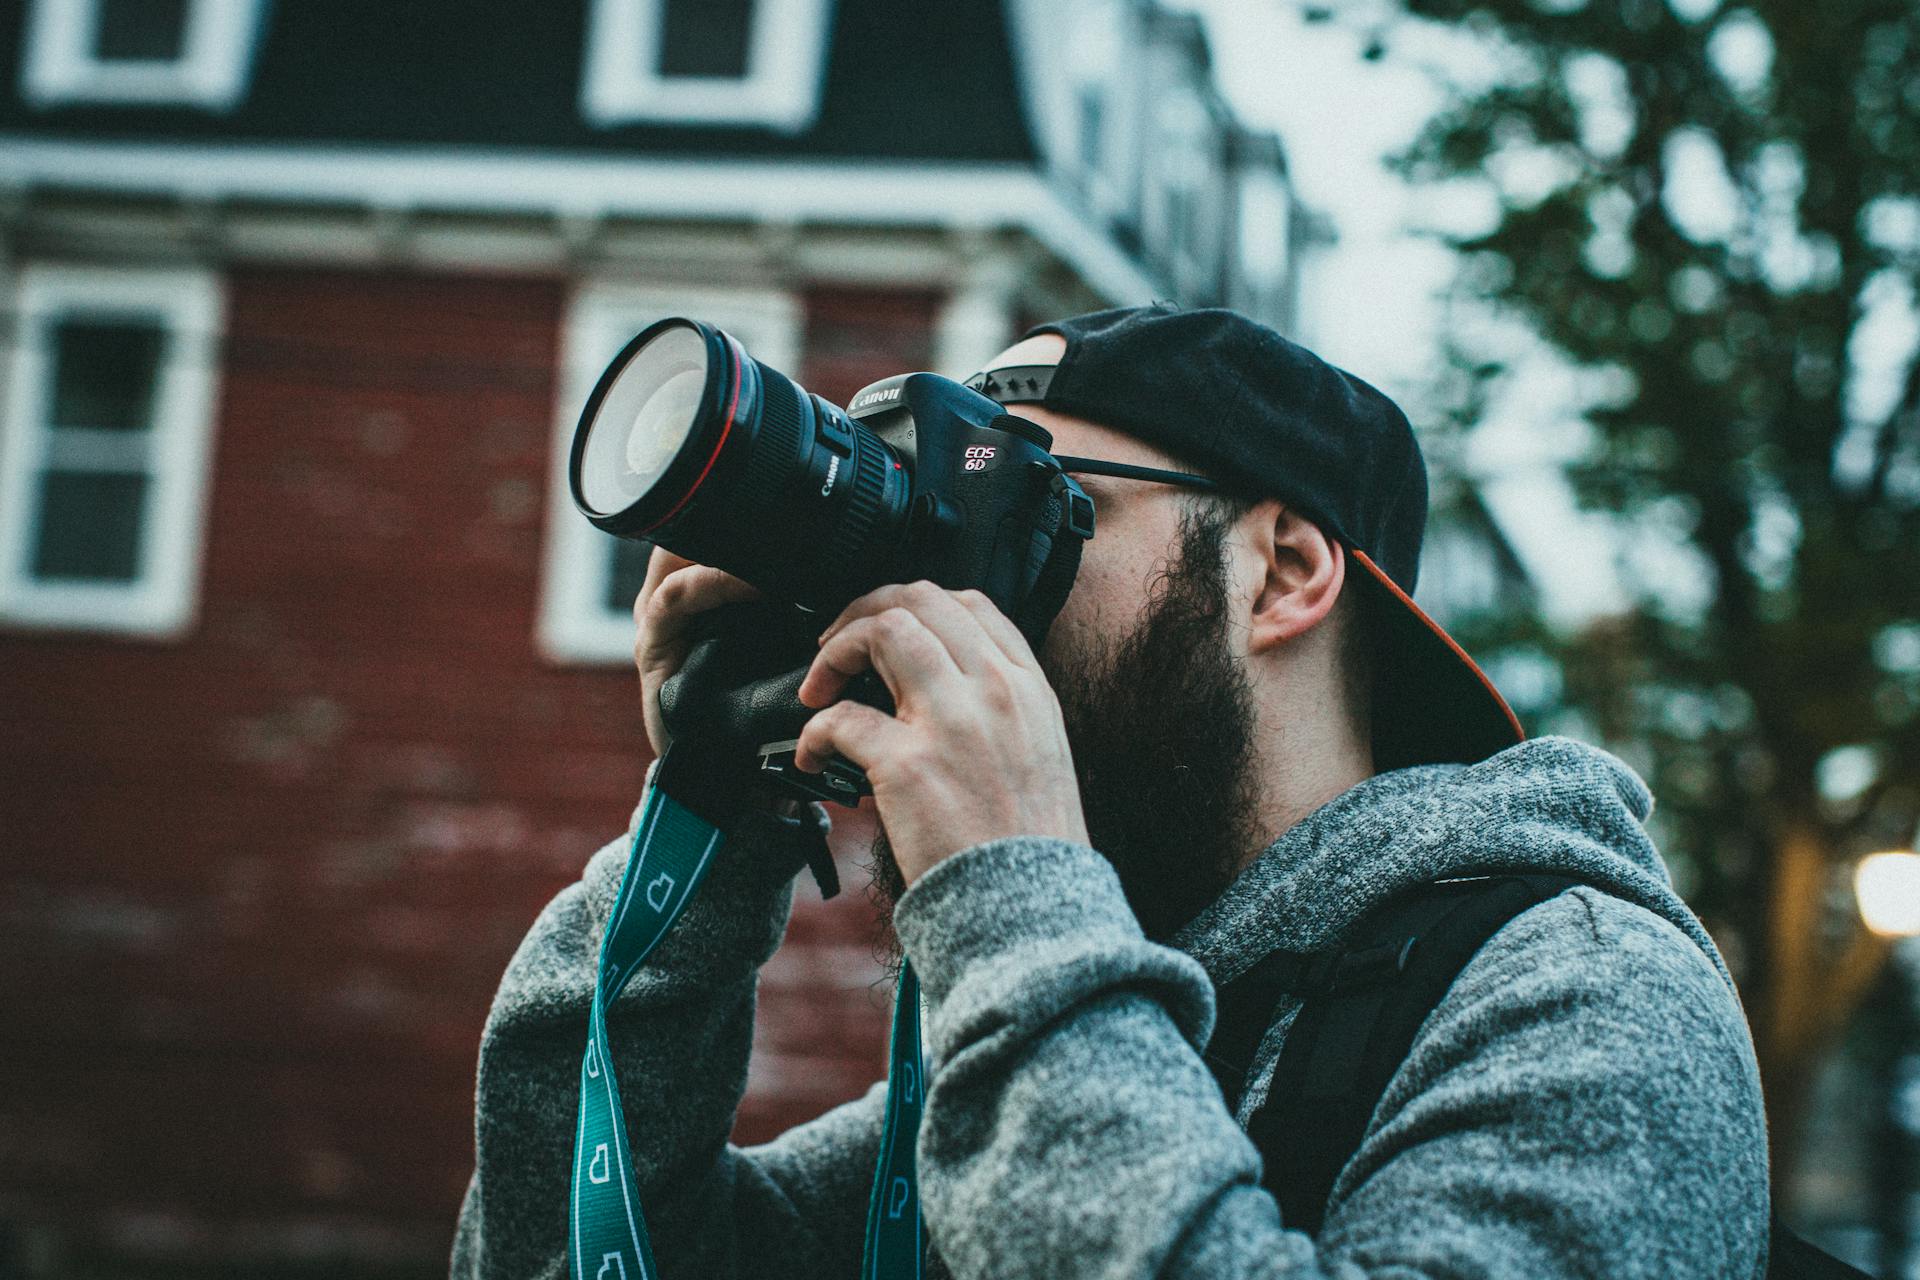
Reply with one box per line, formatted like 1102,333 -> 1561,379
0,0 -> 1035,161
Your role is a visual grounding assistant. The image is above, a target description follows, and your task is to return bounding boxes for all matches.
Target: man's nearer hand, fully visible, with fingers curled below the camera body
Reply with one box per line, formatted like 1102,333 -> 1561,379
795,581 -> 1087,885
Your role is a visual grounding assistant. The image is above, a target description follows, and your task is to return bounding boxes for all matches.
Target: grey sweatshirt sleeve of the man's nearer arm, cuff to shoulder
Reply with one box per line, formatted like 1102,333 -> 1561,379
895,837 -> 1766,1280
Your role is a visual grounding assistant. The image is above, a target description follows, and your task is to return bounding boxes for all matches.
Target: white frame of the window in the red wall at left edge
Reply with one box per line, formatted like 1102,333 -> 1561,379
0,265 -> 225,637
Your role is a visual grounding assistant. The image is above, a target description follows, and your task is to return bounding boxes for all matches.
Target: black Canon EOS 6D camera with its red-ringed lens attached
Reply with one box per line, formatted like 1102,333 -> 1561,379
568,319 -> 1094,804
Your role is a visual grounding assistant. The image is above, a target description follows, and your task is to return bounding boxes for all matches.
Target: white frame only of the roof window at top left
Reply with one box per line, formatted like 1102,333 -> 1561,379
19,0 -> 261,111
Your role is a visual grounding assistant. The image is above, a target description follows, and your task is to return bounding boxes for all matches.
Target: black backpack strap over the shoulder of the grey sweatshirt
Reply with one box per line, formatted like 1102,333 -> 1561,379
1208,875 -> 1584,1232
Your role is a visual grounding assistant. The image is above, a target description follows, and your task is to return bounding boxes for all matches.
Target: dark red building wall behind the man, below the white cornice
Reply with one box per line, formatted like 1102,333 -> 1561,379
0,269 -> 939,1274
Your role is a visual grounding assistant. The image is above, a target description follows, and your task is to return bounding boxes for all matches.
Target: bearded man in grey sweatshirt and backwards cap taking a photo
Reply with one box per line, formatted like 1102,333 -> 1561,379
453,307 -> 1768,1280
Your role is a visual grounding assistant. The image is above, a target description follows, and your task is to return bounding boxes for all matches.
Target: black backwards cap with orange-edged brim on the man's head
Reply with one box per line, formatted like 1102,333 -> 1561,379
968,303 -> 1526,771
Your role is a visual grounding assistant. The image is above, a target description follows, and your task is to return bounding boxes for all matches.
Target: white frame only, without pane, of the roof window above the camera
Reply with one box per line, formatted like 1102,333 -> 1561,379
580,0 -> 831,132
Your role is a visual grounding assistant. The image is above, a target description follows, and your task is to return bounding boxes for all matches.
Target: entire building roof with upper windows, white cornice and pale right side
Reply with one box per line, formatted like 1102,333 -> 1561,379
0,0 -> 1309,324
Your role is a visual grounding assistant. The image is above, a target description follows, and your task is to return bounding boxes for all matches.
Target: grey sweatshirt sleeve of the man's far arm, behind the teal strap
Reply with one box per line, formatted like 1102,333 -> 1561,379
451,786 -> 881,1280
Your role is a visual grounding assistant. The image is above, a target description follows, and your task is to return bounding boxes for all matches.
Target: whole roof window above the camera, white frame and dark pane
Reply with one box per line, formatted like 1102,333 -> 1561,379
580,0 -> 831,132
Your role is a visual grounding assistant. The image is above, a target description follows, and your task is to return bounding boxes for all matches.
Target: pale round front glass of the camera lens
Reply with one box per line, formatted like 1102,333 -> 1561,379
580,324 -> 707,516
